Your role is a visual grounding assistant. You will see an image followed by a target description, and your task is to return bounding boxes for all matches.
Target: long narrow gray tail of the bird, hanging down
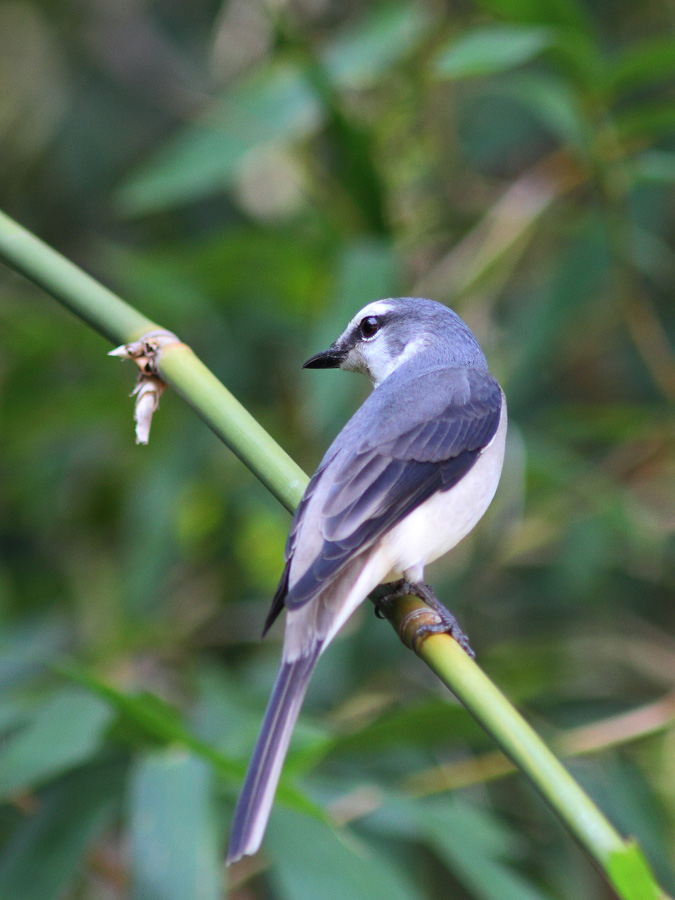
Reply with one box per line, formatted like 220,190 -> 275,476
227,646 -> 321,865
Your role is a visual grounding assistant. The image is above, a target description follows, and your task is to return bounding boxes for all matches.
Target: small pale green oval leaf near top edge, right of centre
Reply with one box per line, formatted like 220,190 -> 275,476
435,25 -> 554,80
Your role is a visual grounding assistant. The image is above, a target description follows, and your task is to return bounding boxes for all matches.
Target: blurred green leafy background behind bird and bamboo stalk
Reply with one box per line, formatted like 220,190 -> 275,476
0,0 -> 675,900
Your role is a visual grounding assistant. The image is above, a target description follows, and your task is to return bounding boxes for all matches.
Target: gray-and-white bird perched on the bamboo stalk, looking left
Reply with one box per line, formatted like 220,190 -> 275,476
227,297 -> 506,864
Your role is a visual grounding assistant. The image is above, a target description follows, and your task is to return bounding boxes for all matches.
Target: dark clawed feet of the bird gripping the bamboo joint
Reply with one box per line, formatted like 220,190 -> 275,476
374,578 -> 476,659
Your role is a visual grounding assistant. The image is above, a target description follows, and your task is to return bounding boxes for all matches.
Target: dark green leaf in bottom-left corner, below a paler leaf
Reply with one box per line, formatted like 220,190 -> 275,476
0,764 -> 125,900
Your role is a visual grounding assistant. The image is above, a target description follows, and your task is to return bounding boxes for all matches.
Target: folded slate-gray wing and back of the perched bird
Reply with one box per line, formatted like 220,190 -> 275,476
265,368 -> 502,630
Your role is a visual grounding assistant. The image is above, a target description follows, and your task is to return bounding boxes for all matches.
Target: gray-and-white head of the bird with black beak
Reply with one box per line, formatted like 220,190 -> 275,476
303,297 -> 486,387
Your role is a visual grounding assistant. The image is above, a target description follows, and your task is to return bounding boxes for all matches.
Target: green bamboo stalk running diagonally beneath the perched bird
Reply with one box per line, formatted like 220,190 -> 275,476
0,213 -> 666,900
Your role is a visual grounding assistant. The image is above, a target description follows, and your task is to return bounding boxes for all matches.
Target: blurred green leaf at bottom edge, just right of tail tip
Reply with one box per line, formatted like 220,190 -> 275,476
265,810 -> 422,900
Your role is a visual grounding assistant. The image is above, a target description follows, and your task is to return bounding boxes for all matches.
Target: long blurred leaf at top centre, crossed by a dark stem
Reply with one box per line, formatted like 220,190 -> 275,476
117,4 -> 428,216
